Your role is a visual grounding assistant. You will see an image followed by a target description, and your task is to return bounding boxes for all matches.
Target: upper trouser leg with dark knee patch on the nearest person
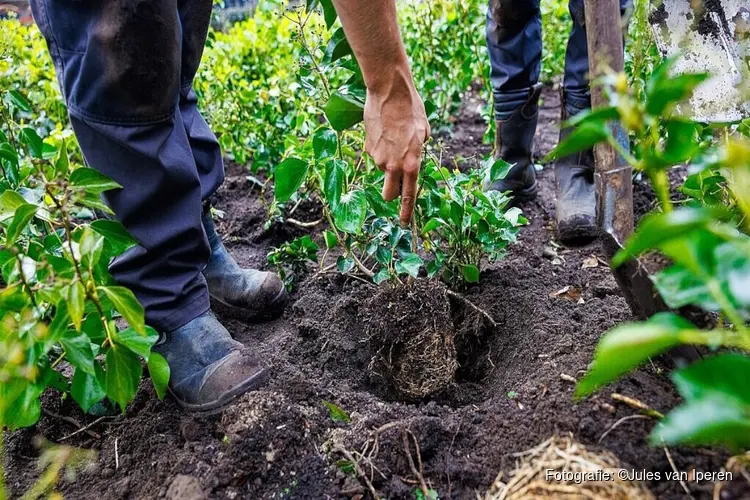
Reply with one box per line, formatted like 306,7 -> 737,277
32,0 -> 181,125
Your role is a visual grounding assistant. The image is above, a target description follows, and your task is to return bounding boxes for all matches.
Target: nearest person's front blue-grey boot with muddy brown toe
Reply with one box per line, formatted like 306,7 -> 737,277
154,311 -> 269,415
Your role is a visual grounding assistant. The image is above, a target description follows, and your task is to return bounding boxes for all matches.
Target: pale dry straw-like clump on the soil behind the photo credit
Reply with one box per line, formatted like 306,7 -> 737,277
485,437 -> 654,500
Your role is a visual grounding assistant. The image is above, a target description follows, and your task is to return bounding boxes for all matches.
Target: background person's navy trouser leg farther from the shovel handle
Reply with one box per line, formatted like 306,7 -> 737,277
486,0 -> 542,120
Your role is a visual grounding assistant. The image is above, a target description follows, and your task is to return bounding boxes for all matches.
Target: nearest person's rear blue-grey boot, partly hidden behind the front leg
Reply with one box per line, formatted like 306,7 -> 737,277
203,209 -> 287,317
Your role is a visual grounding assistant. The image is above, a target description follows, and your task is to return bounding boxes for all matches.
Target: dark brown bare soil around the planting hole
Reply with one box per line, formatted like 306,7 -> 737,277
6,89 -> 726,500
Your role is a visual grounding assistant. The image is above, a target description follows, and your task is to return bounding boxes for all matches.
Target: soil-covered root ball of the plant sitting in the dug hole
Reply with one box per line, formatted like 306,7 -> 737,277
363,280 -> 458,400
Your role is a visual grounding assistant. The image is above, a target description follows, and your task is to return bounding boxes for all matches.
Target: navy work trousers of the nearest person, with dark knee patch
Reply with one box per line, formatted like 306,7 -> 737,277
31,0 -> 224,331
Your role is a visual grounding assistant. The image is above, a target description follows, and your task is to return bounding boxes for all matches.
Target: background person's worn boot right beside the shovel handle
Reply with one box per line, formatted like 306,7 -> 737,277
555,102 -> 599,242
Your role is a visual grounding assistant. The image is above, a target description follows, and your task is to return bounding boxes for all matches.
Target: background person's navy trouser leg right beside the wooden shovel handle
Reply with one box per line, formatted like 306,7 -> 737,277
563,0 -> 631,110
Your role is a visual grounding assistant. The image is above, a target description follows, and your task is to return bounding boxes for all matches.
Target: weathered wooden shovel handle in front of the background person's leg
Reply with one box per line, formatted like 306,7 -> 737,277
585,0 -> 633,242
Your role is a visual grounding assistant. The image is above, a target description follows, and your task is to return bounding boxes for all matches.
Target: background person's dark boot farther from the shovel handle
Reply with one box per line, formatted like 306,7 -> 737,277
485,83 -> 542,201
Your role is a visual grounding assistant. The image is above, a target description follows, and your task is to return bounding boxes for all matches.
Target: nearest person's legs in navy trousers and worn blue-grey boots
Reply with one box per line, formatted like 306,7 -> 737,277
31,0 -> 285,409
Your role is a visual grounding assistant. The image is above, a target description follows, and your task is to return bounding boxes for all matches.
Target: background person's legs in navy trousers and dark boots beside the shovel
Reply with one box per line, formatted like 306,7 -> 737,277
486,0 -> 630,240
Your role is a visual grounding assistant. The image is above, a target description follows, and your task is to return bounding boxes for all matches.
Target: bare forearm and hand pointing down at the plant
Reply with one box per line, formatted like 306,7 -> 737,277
333,0 -> 430,224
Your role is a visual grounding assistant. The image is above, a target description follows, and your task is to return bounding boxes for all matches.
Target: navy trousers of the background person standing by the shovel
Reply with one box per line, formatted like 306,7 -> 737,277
487,0 -> 630,119
